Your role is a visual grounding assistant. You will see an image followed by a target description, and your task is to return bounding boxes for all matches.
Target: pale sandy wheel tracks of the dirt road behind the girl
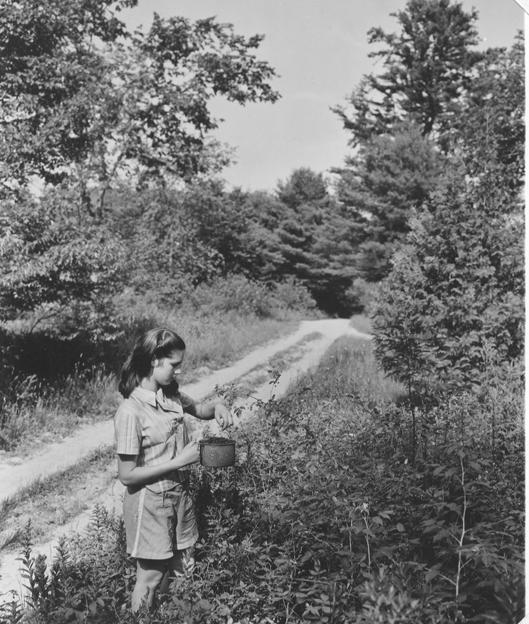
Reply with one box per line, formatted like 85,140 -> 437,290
0,319 -> 369,601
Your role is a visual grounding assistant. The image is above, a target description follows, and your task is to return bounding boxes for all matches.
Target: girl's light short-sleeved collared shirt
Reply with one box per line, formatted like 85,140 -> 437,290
114,387 -> 189,492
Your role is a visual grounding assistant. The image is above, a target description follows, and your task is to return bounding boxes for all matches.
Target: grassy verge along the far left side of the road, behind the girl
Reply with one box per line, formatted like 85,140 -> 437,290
0,282 -> 314,453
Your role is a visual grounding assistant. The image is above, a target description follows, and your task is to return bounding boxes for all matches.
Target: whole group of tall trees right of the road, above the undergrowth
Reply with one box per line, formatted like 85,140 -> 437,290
330,0 -> 524,408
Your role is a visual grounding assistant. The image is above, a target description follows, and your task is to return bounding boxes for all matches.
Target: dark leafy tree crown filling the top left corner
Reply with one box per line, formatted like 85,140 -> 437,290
0,0 -> 134,193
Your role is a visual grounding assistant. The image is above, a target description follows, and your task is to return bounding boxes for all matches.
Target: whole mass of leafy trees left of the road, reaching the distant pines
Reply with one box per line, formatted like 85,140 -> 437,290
0,0 -> 350,342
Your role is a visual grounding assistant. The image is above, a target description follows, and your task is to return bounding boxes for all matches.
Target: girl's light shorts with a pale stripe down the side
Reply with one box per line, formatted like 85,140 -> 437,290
123,485 -> 198,559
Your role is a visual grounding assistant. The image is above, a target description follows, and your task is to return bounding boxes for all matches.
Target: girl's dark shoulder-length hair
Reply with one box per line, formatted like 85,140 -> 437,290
118,327 -> 186,398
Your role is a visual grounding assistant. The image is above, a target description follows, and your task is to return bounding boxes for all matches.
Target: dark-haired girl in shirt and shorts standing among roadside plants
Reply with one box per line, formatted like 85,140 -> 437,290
114,328 -> 233,611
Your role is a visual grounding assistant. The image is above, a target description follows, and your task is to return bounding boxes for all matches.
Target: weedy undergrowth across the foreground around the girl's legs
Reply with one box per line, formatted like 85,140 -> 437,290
3,339 -> 523,624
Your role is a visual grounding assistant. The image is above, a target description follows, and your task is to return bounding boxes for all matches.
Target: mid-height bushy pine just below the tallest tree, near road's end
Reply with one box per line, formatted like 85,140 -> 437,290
336,124 -> 441,281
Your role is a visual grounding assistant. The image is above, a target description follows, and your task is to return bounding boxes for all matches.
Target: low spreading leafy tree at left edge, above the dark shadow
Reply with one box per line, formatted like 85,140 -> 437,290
0,200 -> 125,334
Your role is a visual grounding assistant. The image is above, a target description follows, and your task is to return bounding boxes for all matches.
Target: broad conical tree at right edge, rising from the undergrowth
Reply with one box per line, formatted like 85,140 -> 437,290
368,34 -> 524,392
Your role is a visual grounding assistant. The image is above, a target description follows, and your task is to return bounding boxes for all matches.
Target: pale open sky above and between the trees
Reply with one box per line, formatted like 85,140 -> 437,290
121,0 -> 524,190
